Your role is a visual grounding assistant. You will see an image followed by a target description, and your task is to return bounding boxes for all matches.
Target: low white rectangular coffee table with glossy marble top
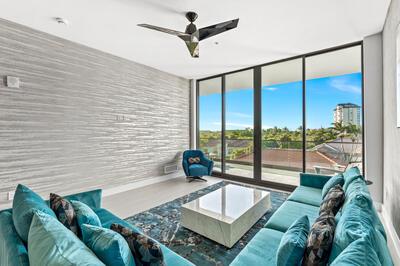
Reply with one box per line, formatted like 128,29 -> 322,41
181,184 -> 271,248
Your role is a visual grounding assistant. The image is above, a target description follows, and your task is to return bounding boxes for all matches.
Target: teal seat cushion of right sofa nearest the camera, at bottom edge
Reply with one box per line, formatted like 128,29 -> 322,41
230,228 -> 283,266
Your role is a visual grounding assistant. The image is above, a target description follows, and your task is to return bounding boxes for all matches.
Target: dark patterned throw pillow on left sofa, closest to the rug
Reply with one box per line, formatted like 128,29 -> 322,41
111,223 -> 165,266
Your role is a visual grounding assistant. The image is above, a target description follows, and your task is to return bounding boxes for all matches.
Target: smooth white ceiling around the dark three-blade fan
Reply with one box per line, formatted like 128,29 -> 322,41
0,0 -> 390,78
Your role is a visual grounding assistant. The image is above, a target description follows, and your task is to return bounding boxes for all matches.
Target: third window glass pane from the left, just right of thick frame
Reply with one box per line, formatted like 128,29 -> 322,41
261,59 -> 303,186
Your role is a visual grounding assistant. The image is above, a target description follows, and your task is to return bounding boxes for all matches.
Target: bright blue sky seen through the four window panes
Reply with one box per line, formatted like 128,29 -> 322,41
200,73 -> 362,130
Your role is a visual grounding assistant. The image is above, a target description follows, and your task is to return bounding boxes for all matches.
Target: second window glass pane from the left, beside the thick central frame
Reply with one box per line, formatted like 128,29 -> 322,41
225,69 -> 254,178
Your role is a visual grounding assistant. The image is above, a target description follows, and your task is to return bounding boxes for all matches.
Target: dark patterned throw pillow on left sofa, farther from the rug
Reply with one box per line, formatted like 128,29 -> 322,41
50,193 -> 78,235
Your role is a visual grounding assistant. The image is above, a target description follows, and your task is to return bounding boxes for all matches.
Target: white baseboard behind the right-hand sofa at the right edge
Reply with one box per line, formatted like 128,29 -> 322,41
379,205 -> 400,266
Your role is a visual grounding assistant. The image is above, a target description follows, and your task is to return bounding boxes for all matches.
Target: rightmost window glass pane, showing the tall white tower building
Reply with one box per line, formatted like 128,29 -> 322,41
306,46 -> 362,174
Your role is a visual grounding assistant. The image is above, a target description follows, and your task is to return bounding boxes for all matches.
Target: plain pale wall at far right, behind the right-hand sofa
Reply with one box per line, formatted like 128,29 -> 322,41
382,0 -> 400,260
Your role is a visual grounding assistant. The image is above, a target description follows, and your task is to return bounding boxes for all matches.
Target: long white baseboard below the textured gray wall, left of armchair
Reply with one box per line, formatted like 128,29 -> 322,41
102,171 -> 185,197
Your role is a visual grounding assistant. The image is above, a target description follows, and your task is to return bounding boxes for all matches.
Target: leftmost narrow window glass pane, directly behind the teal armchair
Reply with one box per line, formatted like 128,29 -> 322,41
198,78 -> 222,172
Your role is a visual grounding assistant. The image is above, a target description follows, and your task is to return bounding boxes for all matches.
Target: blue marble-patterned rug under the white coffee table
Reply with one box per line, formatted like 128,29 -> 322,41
125,181 -> 289,266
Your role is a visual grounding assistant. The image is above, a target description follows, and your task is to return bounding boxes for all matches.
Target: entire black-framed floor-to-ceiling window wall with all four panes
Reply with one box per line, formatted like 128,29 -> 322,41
197,43 -> 363,186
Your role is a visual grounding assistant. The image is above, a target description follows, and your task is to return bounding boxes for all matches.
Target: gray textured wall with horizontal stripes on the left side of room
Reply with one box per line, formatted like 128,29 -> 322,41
0,19 -> 190,207
